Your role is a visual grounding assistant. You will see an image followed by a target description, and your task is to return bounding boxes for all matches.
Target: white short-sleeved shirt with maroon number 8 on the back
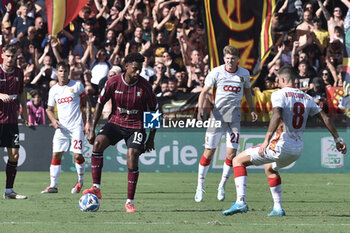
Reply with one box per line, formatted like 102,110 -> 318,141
269,87 -> 321,150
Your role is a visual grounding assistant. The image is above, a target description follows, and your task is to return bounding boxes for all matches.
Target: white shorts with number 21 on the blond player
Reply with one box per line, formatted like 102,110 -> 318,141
205,121 -> 240,149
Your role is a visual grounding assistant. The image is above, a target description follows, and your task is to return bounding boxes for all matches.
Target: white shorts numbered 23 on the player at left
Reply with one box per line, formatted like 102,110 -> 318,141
52,127 -> 84,154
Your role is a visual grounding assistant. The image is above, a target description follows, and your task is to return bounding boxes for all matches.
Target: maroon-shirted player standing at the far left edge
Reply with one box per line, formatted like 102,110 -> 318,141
0,45 -> 29,199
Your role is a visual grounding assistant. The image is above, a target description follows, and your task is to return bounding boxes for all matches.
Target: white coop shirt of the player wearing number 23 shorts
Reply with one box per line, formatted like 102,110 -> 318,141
47,80 -> 86,131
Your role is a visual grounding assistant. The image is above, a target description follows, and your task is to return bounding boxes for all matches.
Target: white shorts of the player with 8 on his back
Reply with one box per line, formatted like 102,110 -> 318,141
245,146 -> 301,171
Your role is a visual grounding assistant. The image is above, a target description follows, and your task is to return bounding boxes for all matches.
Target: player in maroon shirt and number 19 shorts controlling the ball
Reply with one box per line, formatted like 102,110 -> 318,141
83,53 -> 158,212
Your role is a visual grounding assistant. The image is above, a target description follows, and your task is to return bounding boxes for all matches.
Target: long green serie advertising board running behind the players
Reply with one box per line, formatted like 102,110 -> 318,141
0,126 -> 350,173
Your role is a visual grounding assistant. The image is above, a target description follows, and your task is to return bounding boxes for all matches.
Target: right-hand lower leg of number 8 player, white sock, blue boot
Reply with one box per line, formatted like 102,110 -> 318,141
265,163 -> 286,216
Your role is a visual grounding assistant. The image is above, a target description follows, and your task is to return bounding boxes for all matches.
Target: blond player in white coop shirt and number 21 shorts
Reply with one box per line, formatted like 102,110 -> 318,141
194,46 -> 258,202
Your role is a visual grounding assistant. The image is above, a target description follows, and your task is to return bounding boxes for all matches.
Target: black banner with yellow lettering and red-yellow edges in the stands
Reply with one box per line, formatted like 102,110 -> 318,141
204,0 -> 276,83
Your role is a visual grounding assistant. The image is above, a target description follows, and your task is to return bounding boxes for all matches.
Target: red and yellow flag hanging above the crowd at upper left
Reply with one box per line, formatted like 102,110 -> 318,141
45,0 -> 88,36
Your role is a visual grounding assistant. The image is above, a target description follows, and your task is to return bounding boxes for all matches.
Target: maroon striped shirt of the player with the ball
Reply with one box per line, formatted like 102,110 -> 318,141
98,73 -> 158,129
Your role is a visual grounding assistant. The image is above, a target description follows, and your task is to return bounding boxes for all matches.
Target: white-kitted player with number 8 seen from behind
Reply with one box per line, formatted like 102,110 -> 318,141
222,66 -> 346,216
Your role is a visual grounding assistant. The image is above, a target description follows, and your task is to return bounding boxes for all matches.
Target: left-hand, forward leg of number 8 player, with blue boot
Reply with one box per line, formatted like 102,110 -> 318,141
222,151 -> 252,215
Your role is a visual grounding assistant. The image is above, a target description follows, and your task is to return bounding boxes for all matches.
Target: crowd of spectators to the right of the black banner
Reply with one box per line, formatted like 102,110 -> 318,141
256,0 -> 350,112
